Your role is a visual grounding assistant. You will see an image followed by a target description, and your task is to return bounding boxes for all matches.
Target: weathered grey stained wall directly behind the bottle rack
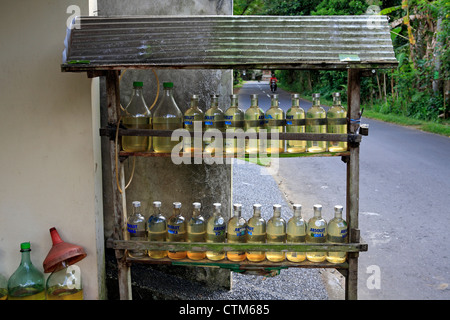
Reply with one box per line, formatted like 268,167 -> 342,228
98,0 -> 232,296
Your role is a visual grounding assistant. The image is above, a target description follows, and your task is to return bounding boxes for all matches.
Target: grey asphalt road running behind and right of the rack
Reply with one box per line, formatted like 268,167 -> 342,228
239,82 -> 450,300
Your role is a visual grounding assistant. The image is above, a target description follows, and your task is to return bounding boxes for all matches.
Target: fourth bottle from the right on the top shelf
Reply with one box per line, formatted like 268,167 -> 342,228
264,94 -> 285,153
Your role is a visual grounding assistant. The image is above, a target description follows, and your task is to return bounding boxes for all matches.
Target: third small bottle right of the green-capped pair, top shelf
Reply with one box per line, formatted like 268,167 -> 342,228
224,94 -> 245,154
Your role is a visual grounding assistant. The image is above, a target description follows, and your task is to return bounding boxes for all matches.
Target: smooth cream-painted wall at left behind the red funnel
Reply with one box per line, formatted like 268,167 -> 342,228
0,0 -> 105,299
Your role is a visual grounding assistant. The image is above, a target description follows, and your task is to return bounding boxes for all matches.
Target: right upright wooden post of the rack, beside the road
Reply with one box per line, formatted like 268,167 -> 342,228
345,69 -> 361,300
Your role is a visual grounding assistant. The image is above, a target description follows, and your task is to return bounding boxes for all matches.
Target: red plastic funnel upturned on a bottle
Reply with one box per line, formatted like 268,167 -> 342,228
43,227 -> 86,273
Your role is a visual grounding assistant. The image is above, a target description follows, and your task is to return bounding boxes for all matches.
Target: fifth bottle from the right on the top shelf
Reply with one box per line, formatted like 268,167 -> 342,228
244,94 -> 264,154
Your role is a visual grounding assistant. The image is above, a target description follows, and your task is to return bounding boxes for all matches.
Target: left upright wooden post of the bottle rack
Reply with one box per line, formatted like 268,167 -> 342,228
106,71 -> 132,300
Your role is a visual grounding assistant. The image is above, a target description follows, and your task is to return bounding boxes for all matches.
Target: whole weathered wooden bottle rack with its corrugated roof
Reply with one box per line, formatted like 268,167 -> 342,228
62,16 -> 397,299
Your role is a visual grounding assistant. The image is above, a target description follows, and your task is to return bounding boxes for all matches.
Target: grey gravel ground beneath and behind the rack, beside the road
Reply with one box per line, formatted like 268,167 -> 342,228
107,160 -> 329,300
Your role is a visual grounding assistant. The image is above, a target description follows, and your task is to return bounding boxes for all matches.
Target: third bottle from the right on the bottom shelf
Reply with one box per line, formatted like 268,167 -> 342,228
286,204 -> 306,262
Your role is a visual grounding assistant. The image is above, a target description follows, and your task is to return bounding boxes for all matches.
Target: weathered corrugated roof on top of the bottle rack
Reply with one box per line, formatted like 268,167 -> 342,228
62,15 -> 397,71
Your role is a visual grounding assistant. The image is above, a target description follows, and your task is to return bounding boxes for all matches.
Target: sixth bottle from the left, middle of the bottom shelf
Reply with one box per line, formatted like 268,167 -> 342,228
227,203 -> 247,261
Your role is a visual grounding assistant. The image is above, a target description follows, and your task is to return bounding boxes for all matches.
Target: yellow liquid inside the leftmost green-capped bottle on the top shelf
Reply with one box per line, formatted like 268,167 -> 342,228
122,117 -> 152,152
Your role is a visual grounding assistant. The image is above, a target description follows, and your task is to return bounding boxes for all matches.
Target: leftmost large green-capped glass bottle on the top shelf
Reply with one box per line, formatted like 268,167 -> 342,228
122,81 -> 152,152
